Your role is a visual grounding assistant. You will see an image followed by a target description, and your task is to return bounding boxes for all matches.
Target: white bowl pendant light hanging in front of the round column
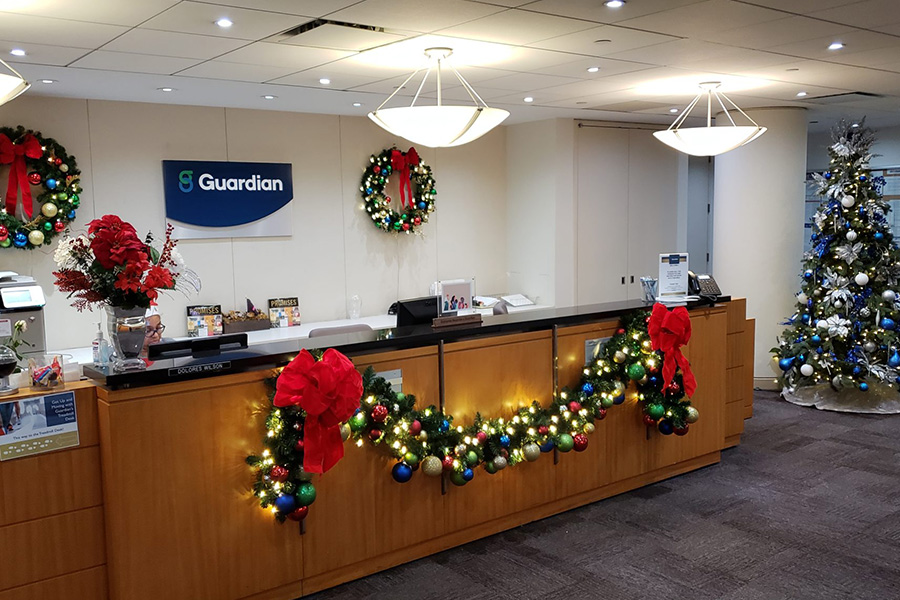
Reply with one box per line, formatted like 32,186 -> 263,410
653,81 -> 766,156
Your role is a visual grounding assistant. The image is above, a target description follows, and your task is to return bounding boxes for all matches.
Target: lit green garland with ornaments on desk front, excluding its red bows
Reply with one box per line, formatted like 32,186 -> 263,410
247,311 -> 699,521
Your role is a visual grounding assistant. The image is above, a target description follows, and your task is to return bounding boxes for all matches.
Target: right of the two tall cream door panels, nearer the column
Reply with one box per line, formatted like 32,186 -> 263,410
627,129 -> 684,298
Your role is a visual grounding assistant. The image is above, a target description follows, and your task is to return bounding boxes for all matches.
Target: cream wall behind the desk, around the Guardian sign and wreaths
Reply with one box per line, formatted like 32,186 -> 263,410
0,95 -> 512,348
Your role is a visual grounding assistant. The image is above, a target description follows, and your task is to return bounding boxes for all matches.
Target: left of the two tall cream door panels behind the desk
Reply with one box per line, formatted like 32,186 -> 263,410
575,127 -> 628,305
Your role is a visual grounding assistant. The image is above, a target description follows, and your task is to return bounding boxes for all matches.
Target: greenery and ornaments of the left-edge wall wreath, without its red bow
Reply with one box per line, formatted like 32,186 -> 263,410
0,125 -> 82,250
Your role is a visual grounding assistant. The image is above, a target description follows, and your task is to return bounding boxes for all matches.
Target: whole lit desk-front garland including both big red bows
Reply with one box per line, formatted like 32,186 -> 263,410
247,305 -> 699,521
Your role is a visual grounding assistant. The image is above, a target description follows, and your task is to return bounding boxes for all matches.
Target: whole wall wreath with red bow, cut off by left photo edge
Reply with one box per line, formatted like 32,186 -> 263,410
0,125 -> 82,250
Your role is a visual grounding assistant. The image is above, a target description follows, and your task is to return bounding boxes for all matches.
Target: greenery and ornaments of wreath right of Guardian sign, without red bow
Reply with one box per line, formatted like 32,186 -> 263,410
359,147 -> 437,233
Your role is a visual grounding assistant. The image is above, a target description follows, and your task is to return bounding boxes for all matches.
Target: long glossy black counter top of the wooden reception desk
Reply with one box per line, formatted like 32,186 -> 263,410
84,296 -> 731,389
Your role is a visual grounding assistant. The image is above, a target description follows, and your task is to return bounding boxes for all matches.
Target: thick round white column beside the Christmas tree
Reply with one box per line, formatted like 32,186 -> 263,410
713,108 -> 807,384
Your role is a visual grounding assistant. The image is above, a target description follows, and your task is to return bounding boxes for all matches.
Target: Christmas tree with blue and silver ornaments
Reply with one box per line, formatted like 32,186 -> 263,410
772,121 -> 900,396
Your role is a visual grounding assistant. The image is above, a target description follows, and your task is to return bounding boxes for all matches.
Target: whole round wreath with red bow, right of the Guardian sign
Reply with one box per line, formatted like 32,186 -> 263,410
359,148 -> 437,233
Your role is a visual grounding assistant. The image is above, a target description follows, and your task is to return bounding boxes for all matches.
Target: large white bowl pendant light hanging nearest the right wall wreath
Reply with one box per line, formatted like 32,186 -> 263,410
369,48 -> 509,148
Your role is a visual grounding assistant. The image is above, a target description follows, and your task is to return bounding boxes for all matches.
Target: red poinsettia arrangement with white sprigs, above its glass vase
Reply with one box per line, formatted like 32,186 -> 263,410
53,215 -> 200,311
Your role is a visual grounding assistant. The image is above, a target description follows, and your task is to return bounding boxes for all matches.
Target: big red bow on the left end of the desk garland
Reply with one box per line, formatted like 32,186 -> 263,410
272,348 -> 362,473
